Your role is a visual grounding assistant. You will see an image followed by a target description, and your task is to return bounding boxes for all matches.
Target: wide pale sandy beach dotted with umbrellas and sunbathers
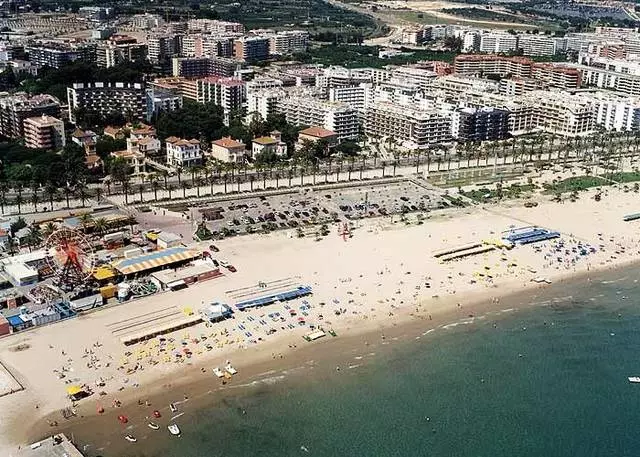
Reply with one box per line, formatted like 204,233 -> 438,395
0,183 -> 640,456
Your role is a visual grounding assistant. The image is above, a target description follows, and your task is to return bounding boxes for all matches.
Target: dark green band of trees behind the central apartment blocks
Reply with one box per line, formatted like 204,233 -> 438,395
295,45 -> 456,68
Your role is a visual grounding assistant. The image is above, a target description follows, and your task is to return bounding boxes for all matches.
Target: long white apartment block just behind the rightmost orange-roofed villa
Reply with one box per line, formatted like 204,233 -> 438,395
276,97 -> 360,140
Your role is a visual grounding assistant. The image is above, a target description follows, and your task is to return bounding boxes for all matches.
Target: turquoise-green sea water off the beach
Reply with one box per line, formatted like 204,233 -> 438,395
91,268 -> 640,457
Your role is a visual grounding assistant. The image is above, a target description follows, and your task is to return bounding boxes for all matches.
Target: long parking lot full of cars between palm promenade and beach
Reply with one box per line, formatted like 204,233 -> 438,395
175,181 -> 449,237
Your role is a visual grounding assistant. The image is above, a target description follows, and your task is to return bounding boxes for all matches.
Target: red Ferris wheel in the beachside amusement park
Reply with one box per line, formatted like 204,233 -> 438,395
44,227 -> 95,288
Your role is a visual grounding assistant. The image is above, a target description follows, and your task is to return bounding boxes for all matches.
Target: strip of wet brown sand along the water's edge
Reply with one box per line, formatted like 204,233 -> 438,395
30,260 -> 640,456
